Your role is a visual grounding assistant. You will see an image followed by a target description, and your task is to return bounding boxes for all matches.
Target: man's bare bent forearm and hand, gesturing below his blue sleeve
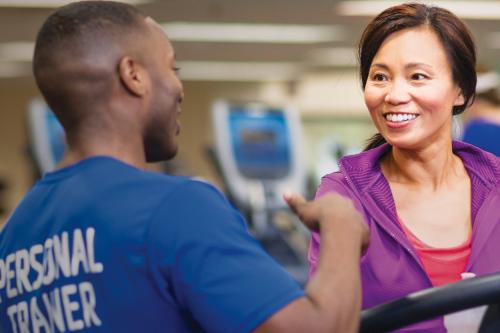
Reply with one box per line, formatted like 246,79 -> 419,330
255,194 -> 369,333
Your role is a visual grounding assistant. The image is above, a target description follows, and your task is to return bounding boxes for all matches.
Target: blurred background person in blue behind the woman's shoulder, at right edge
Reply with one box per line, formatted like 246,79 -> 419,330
462,72 -> 500,156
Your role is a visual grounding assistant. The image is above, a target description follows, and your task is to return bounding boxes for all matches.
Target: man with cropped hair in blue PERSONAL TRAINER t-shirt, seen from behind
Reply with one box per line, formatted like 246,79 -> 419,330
0,1 -> 367,332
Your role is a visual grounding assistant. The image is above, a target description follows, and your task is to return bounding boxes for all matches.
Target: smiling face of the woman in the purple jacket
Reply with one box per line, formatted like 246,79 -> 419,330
364,27 -> 464,149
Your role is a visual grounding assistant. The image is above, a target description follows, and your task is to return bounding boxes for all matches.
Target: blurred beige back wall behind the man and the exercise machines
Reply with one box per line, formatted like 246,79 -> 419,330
0,72 -> 373,224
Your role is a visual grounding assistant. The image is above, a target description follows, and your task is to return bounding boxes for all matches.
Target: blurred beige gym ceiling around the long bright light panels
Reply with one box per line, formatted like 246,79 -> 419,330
0,0 -> 500,81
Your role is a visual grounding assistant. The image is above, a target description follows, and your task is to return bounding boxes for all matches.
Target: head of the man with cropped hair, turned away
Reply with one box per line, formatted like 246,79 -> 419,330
33,1 -> 183,161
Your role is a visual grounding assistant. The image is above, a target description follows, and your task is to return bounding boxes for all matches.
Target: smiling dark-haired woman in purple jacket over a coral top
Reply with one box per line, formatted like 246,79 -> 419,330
309,4 -> 500,332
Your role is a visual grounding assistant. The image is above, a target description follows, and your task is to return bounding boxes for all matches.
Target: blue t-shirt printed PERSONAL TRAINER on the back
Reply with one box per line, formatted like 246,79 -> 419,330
0,157 -> 303,333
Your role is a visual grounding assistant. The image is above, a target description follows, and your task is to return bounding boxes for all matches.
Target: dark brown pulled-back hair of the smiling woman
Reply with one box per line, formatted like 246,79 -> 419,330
358,3 -> 477,150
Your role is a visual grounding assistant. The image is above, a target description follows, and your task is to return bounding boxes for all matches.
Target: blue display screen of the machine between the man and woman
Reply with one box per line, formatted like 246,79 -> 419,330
229,106 -> 291,179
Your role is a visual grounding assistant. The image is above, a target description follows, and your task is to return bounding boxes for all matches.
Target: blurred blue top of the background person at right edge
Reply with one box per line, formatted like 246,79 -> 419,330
463,119 -> 500,156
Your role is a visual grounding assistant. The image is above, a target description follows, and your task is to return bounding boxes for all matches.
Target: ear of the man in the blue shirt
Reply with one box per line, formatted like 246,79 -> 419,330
118,56 -> 149,96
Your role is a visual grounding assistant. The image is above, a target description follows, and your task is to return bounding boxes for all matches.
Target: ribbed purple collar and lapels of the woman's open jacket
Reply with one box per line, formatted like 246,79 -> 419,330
340,141 -> 500,267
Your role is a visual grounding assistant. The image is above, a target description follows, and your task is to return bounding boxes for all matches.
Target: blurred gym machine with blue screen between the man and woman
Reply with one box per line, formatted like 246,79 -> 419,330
212,100 -> 309,283
